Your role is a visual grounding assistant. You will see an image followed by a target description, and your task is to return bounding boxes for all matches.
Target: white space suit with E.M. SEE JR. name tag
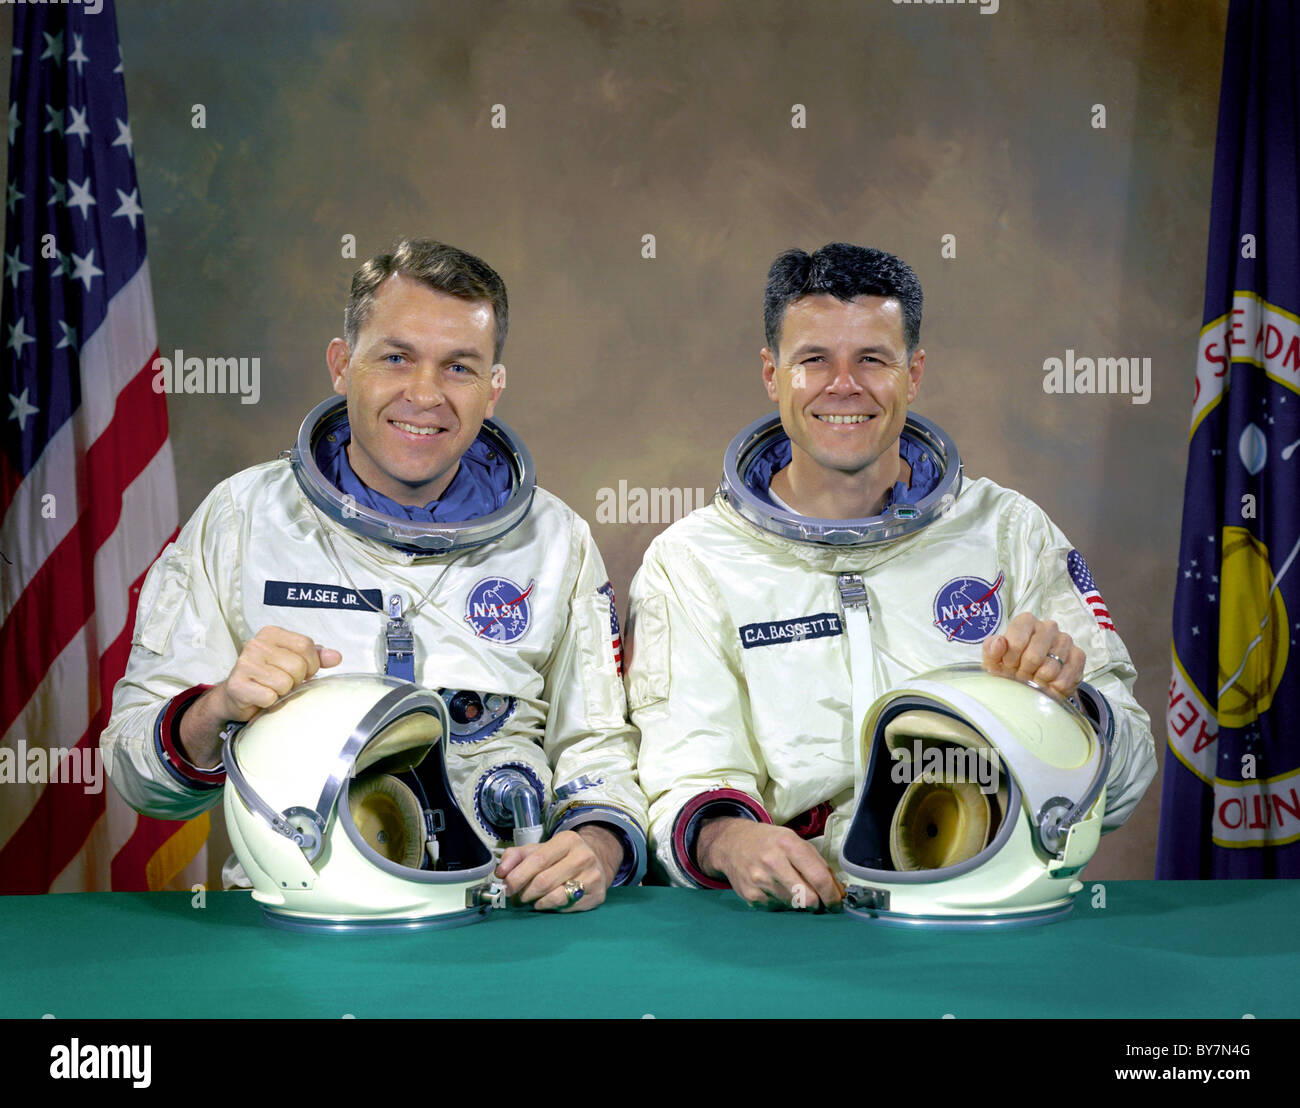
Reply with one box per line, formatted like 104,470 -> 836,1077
100,401 -> 646,884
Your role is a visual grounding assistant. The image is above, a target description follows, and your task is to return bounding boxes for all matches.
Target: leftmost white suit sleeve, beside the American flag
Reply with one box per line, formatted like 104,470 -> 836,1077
100,484 -> 241,819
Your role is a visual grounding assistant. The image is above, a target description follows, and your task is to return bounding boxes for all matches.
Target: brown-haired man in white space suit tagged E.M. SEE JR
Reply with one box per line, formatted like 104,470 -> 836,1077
101,241 -> 646,910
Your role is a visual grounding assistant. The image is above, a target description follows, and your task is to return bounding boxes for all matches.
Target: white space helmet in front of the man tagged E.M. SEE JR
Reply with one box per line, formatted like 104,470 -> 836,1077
225,674 -> 497,930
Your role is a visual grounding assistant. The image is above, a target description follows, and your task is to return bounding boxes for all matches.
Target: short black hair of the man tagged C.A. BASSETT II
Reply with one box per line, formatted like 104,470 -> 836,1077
763,242 -> 920,358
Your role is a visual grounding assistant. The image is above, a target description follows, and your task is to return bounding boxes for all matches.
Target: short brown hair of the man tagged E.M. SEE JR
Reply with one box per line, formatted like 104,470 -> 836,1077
343,238 -> 510,362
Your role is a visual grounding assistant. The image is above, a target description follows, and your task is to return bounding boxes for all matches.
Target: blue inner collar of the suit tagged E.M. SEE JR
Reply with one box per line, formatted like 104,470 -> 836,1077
316,421 -> 515,523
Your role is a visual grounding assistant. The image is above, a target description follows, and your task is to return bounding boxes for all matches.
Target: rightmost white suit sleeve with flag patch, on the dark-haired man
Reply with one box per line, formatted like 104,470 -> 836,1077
1008,501 -> 1156,831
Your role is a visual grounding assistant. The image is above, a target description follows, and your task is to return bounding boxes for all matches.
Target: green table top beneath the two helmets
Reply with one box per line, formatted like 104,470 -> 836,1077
0,880 -> 1300,1020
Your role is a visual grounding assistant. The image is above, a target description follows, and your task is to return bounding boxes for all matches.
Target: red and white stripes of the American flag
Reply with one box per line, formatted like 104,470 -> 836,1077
0,264 -> 205,892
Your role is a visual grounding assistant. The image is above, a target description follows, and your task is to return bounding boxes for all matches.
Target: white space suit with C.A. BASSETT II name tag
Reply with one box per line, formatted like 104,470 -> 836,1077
627,416 -> 1156,888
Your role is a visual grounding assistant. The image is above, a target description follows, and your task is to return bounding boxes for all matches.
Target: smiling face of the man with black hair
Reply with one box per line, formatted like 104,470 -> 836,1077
762,295 -> 926,485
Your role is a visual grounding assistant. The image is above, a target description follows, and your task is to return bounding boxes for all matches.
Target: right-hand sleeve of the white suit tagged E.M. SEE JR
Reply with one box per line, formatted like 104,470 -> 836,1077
543,516 -> 646,884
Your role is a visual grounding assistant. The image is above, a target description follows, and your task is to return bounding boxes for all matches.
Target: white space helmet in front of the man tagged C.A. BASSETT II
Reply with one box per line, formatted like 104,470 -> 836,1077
840,665 -> 1113,927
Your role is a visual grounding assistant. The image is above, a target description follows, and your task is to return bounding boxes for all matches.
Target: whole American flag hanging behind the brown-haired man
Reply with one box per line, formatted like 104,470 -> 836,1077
0,0 -> 207,893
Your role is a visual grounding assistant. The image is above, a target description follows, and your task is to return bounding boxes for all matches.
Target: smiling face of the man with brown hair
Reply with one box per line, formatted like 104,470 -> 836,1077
325,274 -> 504,507
